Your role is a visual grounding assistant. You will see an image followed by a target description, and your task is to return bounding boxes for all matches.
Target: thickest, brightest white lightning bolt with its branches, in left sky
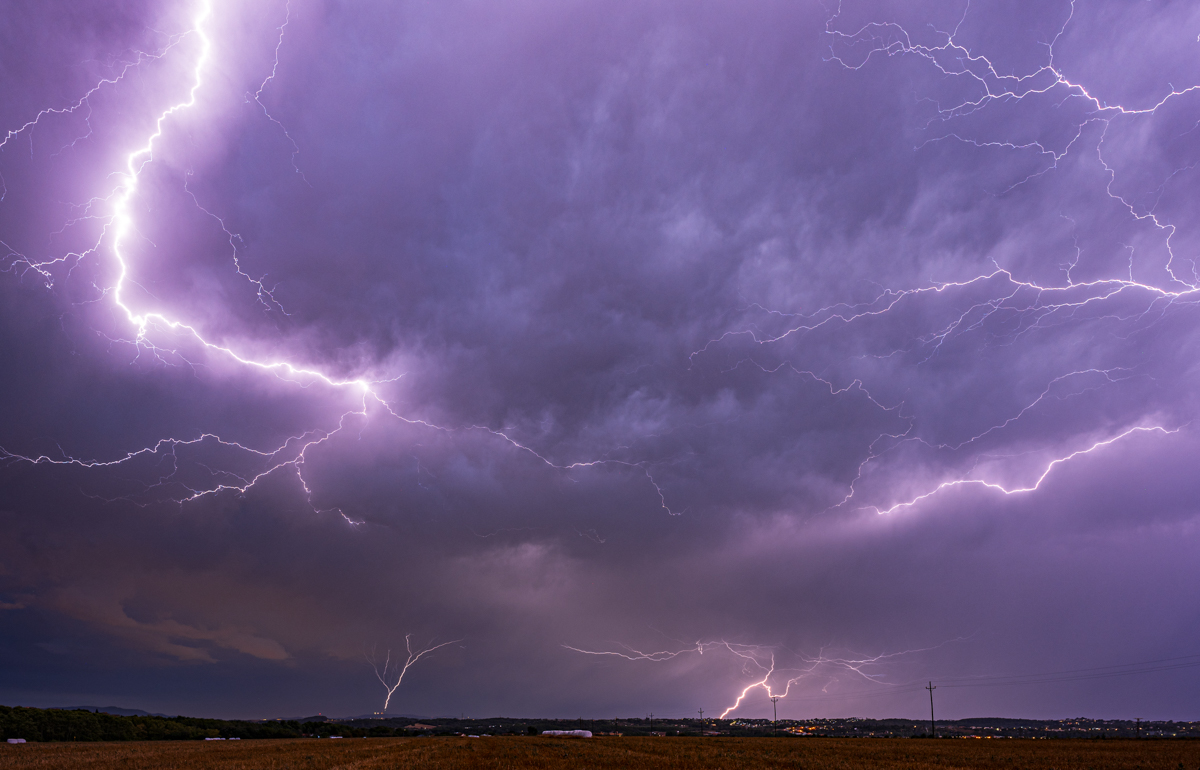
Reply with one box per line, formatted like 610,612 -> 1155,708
0,0 -> 676,515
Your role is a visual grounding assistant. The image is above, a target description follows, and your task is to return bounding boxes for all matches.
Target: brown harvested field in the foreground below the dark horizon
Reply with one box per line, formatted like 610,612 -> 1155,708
0,738 -> 1200,770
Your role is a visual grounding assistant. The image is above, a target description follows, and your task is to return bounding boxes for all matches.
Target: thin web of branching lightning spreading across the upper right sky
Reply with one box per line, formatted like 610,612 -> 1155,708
691,0 -> 1200,513
